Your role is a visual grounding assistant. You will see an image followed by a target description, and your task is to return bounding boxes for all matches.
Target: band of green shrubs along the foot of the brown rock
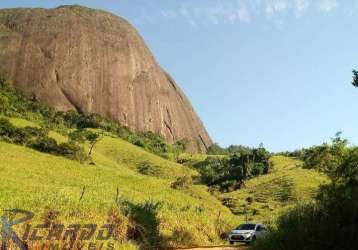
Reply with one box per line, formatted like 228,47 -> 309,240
0,76 -> 186,157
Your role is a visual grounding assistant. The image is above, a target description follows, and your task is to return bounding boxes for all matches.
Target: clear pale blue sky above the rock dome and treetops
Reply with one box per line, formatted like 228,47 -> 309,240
0,0 -> 358,151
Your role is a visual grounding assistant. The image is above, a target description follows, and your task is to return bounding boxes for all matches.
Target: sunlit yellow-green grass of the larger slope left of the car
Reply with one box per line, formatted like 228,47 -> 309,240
0,118 -> 238,247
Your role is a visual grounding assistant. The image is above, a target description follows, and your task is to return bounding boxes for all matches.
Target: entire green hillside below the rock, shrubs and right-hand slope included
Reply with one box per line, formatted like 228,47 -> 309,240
0,77 -> 327,250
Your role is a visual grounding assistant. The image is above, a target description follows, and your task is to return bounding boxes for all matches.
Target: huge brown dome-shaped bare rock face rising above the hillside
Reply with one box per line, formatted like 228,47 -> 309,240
0,6 -> 212,151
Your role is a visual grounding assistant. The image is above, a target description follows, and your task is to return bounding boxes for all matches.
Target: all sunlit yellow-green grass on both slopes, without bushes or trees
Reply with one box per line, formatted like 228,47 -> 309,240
0,118 -> 327,249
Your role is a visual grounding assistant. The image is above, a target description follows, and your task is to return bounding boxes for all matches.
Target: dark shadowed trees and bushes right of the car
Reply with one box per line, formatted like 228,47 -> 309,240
255,141 -> 358,250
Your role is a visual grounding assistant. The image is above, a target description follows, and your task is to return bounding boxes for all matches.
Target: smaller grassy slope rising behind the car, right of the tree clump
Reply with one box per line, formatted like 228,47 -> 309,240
220,156 -> 328,223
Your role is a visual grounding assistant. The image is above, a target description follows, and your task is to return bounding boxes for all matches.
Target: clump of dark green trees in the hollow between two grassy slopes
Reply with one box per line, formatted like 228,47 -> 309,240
195,147 -> 270,191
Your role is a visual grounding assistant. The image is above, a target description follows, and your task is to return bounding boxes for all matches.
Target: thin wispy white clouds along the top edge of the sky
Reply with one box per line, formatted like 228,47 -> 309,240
153,0 -> 339,27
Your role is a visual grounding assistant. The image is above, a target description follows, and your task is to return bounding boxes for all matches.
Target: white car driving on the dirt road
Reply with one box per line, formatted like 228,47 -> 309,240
229,223 -> 267,244
